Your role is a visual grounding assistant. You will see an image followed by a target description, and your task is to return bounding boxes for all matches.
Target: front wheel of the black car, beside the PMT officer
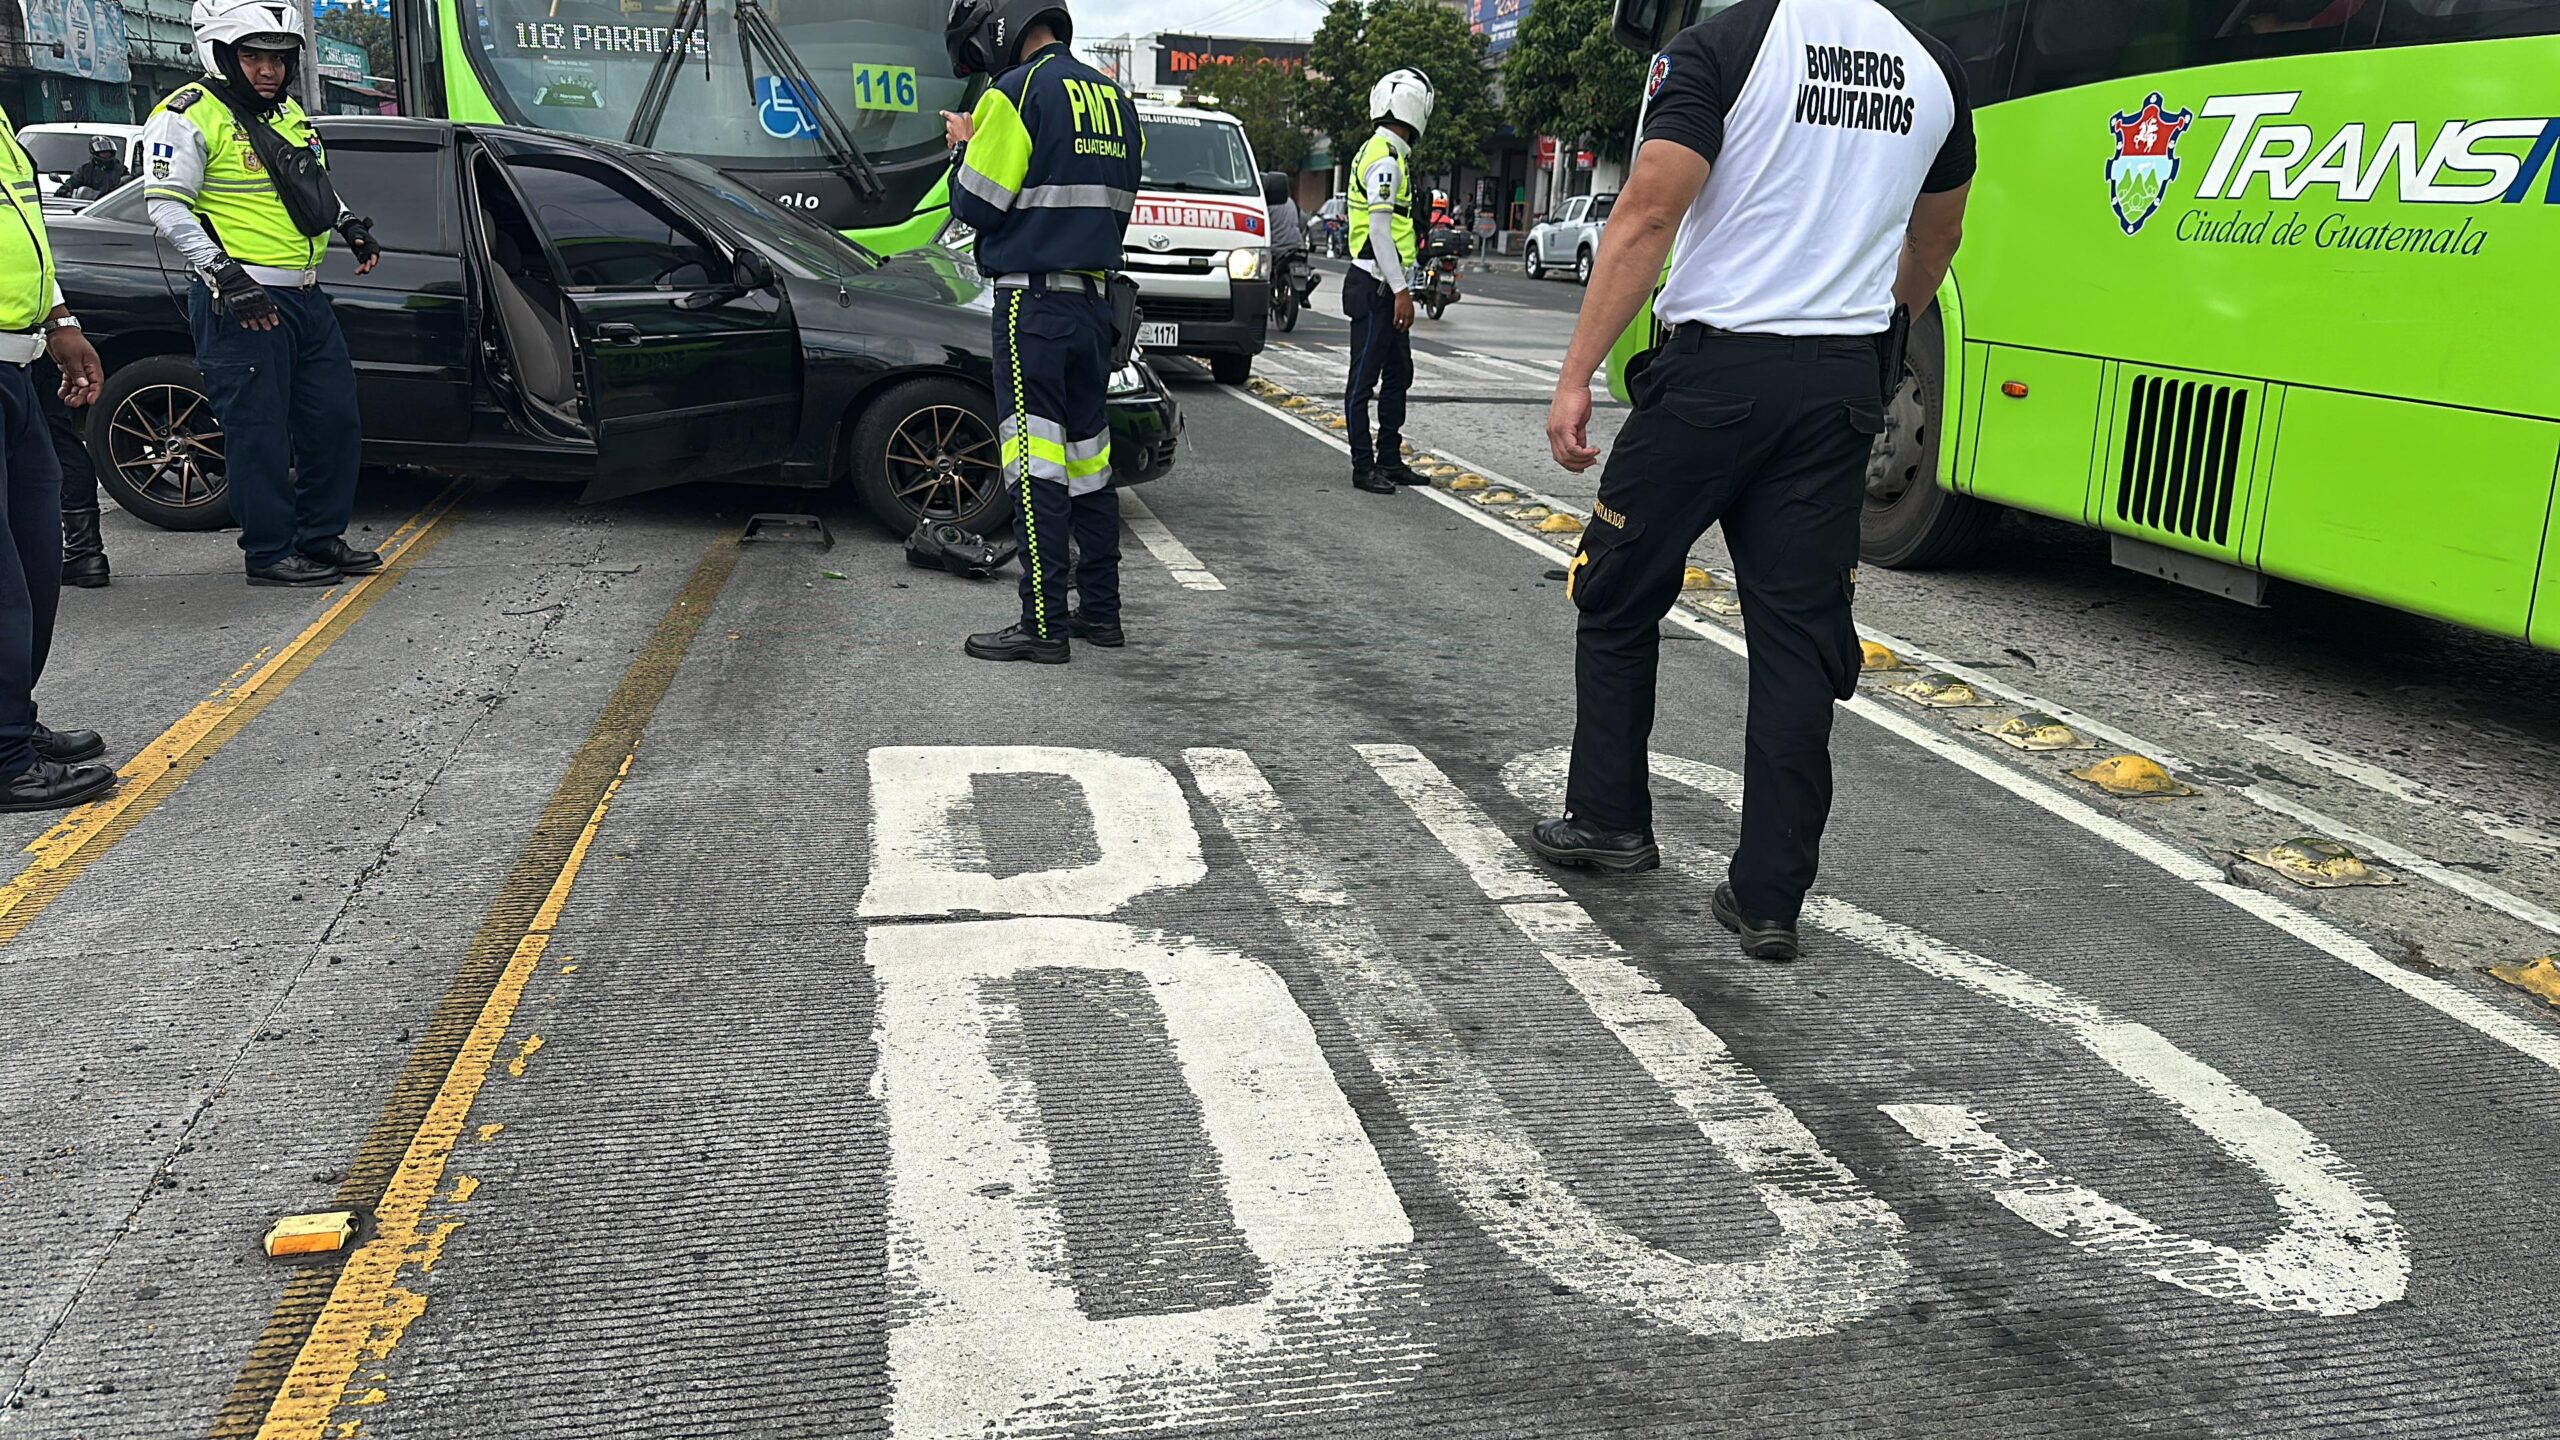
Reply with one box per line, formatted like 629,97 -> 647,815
847,377 -> 1011,536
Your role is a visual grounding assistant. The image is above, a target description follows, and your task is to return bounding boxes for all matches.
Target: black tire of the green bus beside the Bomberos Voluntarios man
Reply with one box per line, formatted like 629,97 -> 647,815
1859,305 -> 1999,569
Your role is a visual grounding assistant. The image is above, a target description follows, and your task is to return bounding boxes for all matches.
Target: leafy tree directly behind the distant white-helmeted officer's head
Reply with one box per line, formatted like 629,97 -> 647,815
1298,0 -> 1498,177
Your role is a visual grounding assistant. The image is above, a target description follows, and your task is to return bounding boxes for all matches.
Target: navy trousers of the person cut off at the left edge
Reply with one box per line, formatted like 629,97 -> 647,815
0,364 -> 61,779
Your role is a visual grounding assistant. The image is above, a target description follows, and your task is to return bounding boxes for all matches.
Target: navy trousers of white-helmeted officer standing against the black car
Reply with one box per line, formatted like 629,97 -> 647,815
187,282 -> 364,566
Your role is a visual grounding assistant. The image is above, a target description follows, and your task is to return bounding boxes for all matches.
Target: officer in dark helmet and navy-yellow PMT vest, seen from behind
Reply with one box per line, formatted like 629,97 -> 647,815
942,0 -> 1144,664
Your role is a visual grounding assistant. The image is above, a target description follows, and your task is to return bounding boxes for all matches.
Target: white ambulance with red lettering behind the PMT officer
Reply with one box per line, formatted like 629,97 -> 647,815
1126,100 -> 1272,384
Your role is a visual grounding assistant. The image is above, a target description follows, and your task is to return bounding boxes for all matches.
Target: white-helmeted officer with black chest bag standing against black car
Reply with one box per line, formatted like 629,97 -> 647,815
143,0 -> 381,584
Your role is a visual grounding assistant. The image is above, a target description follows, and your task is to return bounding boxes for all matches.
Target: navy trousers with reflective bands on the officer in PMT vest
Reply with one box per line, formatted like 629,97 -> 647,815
996,287 -> 1119,641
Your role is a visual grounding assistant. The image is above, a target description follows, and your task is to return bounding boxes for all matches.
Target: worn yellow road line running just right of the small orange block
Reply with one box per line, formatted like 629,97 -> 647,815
212,533 -> 737,1440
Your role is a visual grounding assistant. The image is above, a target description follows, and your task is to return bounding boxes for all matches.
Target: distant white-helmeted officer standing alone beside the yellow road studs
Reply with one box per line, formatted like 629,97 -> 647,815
1341,69 -> 1434,495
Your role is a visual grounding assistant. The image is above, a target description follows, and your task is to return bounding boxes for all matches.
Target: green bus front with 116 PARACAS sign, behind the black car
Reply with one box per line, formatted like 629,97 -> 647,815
389,0 -> 975,254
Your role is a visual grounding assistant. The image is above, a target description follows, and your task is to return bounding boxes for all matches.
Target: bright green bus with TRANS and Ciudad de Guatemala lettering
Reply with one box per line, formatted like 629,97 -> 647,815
1610,0 -> 2560,648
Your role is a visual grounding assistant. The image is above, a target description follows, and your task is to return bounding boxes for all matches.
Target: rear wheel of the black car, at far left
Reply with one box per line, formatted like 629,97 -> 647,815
84,356 -> 230,530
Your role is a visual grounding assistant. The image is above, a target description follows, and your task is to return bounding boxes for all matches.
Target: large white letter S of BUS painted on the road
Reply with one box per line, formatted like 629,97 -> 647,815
1503,748 -> 2409,1314
